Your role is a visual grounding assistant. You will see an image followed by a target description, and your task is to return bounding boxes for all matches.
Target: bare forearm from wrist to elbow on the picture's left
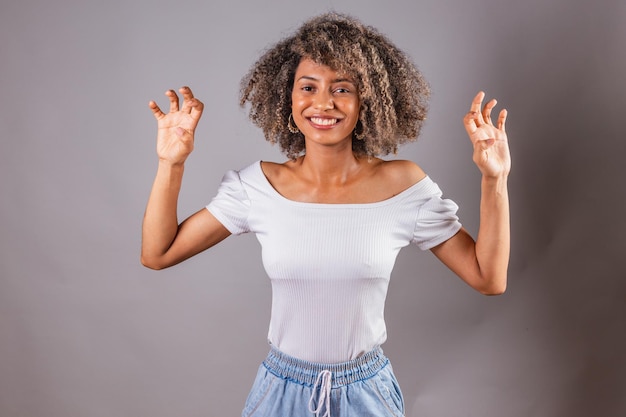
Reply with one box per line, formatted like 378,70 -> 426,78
141,161 -> 184,266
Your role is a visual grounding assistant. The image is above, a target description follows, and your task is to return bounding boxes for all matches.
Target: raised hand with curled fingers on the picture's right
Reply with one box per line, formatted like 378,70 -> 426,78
463,91 -> 511,177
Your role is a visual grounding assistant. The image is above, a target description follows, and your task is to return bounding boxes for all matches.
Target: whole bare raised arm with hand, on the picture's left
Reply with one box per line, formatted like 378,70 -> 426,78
141,87 -> 230,269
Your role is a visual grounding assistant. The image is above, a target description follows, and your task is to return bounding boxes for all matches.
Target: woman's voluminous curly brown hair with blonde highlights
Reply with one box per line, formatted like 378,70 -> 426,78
240,13 -> 430,159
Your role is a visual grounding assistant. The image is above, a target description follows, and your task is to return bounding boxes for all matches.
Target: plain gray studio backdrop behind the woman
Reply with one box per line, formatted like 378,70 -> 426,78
0,0 -> 626,417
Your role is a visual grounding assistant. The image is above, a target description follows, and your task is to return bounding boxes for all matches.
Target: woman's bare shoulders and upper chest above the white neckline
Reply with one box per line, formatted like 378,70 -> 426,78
261,158 -> 426,204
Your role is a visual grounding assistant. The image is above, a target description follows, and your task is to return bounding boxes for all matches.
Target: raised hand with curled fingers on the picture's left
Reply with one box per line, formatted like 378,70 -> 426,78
148,87 -> 204,165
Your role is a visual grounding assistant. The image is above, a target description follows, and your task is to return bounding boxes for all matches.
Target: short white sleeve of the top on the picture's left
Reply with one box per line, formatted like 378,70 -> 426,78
206,171 -> 250,235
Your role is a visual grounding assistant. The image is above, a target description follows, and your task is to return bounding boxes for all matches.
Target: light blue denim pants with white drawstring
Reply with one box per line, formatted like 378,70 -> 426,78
242,347 -> 404,417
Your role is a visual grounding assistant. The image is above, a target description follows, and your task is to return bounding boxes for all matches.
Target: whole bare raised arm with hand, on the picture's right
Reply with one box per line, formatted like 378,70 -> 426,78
432,92 -> 511,295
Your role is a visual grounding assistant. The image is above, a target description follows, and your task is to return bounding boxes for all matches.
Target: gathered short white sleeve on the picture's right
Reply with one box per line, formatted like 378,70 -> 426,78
412,181 -> 461,250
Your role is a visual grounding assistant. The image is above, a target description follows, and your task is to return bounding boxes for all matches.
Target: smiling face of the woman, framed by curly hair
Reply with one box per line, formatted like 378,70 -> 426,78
291,58 -> 360,150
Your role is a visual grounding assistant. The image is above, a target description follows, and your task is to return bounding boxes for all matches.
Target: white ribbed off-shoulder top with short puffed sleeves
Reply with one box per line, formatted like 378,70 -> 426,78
207,162 -> 461,363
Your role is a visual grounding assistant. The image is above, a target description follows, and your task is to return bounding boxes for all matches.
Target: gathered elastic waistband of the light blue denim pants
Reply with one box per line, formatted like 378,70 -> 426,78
263,346 -> 389,388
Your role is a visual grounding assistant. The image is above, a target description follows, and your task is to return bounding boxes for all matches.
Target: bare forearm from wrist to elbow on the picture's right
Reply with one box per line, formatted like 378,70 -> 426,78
476,175 -> 511,294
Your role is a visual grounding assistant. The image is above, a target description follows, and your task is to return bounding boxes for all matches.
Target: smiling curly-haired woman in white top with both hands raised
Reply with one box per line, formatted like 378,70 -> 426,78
142,14 -> 510,417
